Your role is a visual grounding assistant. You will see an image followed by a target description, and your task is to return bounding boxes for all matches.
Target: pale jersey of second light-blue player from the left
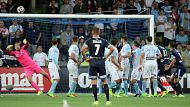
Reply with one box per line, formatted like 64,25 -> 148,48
69,44 -> 79,63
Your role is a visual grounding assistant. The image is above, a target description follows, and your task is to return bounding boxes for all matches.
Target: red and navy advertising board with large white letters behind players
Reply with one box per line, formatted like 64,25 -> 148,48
0,67 -> 190,93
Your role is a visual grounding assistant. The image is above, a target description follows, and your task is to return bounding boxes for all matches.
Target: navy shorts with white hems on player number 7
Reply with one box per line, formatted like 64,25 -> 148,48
89,66 -> 107,79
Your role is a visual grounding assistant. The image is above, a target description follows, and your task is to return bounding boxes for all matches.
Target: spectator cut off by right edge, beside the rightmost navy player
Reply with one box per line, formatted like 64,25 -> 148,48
182,42 -> 190,67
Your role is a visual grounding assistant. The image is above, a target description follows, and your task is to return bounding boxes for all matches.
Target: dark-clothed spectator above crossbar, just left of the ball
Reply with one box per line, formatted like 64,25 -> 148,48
6,0 -> 17,13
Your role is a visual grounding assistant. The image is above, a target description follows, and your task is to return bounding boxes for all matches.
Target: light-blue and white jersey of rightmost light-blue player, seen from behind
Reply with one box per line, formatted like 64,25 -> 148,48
141,44 -> 161,62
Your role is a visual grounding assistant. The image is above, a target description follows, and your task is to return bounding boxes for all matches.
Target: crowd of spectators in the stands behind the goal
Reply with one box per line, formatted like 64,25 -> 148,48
0,0 -> 190,67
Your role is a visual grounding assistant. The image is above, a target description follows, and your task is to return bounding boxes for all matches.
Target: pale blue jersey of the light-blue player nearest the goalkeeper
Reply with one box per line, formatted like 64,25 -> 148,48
48,46 -> 59,67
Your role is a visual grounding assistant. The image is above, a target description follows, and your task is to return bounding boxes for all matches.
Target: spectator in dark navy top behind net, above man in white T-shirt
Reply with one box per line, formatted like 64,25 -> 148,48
24,21 -> 42,57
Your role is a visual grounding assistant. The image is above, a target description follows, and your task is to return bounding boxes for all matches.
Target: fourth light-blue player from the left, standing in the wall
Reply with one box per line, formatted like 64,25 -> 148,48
119,36 -> 131,96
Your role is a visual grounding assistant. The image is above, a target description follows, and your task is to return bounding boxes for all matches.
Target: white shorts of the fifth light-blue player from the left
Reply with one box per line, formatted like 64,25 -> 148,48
131,68 -> 142,80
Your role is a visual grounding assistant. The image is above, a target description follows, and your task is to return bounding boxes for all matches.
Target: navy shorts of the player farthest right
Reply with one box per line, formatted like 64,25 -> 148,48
174,67 -> 186,79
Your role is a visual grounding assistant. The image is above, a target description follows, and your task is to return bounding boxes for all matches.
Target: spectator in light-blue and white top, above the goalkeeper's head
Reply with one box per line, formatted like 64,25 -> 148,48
9,20 -> 23,44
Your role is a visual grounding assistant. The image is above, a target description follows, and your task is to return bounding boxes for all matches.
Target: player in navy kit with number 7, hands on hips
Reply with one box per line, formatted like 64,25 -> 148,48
82,27 -> 113,105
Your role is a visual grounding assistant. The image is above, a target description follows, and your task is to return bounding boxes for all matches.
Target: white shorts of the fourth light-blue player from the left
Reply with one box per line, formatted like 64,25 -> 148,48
121,62 -> 130,79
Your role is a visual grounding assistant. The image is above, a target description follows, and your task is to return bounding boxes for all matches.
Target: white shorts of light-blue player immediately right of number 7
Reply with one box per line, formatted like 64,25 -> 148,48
110,66 -> 123,81
